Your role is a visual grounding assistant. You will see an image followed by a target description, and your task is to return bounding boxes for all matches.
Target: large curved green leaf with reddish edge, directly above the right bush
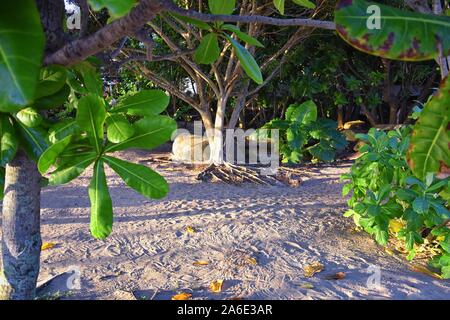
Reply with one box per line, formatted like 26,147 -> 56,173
408,77 -> 450,179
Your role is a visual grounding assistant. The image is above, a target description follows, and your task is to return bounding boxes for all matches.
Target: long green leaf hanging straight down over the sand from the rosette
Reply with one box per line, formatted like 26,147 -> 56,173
89,160 -> 113,239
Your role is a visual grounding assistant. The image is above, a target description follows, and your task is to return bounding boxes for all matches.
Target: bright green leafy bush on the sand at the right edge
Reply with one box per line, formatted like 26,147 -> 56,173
342,127 -> 450,279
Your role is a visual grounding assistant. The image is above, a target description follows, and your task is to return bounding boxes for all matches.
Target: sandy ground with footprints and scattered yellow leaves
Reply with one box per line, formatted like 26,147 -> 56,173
0,152 -> 450,299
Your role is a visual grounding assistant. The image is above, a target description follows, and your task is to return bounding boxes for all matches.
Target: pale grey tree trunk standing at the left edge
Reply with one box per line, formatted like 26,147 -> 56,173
0,151 -> 41,300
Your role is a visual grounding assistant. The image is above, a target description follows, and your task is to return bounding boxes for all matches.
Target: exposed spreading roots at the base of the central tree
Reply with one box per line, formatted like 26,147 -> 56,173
197,163 -> 301,187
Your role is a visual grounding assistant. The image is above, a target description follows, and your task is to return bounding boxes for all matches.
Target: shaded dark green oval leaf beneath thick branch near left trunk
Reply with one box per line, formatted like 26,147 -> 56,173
35,66 -> 67,99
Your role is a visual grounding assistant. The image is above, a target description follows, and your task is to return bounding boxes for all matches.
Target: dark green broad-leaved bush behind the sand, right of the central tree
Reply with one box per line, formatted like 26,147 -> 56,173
262,100 -> 347,163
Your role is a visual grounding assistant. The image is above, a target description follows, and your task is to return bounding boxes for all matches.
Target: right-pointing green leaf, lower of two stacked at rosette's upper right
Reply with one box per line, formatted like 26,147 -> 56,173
105,116 -> 177,152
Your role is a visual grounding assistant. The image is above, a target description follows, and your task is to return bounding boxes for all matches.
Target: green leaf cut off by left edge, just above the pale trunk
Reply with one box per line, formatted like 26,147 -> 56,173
0,114 -> 19,167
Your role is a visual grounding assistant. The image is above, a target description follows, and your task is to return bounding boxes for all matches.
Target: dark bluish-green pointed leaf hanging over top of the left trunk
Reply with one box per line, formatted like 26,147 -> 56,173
16,121 -> 49,162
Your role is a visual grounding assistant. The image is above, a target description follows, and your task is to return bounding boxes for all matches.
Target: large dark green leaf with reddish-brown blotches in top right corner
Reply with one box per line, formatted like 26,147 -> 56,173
335,0 -> 450,61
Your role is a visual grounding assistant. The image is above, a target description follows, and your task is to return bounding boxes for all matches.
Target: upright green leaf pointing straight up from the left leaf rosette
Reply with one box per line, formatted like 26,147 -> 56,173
76,94 -> 106,154
